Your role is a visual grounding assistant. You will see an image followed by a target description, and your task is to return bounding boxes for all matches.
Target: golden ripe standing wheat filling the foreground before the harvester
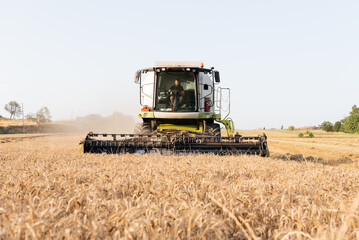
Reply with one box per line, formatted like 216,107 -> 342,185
0,135 -> 359,239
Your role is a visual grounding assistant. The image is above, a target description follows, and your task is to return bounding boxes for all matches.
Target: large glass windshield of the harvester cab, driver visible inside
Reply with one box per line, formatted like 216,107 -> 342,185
155,71 -> 197,112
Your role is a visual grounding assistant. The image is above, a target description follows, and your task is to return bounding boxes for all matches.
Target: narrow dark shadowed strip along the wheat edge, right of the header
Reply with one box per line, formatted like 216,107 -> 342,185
272,153 -> 354,166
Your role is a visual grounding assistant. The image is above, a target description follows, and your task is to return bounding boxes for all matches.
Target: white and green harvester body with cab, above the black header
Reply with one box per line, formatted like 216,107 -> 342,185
135,62 -> 234,137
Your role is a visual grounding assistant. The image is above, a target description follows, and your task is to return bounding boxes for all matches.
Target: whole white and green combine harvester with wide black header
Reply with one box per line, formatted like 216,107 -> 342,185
82,62 -> 269,157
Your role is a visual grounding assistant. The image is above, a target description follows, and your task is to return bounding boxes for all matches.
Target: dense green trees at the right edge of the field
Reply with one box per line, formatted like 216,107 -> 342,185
320,105 -> 359,133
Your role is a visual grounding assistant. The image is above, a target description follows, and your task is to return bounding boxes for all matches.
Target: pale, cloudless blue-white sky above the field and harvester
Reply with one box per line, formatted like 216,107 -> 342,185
0,0 -> 359,128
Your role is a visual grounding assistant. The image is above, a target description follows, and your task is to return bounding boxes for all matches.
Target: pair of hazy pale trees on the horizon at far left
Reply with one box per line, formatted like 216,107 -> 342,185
4,101 -> 51,126
